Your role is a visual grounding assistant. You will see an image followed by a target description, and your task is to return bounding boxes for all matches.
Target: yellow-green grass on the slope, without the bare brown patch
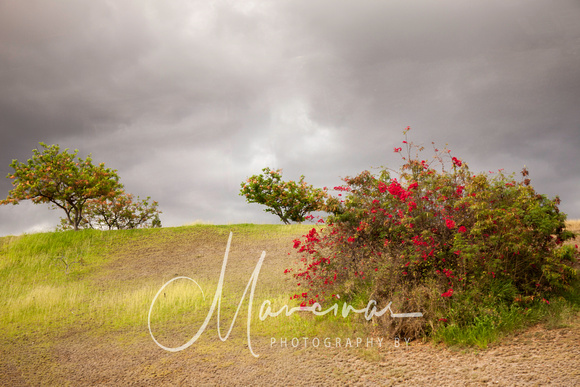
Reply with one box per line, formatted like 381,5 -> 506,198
0,224 -> 370,344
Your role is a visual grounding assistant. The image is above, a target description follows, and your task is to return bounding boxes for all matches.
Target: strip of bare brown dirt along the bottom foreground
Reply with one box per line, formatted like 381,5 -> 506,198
0,324 -> 580,386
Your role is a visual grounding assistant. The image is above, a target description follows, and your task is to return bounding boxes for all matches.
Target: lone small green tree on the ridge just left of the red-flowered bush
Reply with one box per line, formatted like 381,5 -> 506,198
240,168 -> 326,224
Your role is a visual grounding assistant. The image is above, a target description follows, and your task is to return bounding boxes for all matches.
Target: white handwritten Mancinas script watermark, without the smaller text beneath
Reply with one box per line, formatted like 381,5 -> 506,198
147,232 -> 423,357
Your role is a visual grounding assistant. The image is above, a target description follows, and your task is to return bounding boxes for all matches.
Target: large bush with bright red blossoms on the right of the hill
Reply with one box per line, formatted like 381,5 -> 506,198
286,128 -> 579,337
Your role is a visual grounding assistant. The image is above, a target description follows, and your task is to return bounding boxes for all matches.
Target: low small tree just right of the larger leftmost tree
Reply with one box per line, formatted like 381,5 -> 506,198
61,192 -> 161,230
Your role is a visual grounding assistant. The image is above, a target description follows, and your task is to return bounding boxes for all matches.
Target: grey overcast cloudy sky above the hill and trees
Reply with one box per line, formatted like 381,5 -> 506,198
0,0 -> 580,235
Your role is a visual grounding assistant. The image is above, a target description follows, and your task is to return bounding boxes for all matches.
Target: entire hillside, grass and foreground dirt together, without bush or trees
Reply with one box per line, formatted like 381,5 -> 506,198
0,225 -> 580,386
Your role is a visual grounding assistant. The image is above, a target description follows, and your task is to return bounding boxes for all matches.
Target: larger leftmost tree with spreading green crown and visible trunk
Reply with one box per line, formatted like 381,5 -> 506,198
0,142 -> 123,230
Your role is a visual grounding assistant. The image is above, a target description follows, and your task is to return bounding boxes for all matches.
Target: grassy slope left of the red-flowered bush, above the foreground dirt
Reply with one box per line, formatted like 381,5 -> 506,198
0,224 -> 372,384
